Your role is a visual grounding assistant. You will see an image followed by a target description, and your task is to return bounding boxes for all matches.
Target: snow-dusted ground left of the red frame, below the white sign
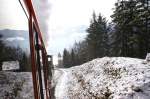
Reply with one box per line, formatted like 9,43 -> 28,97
0,71 -> 34,99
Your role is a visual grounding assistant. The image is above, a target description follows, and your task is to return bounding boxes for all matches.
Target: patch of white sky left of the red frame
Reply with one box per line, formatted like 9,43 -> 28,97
0,0 -> 28,30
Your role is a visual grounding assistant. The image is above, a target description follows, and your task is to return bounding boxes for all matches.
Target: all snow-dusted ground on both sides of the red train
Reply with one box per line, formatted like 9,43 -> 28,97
0,56 -> 150,99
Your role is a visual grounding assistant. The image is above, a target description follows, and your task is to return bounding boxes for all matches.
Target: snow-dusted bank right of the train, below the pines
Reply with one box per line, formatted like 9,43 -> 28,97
54,57 -> 150,99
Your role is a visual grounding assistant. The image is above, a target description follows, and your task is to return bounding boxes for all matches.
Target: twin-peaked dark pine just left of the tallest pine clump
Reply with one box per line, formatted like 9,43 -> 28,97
87,13 -> 108,59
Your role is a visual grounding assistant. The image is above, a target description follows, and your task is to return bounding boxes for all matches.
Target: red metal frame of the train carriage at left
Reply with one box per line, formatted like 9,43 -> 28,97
19,0 -> 51,99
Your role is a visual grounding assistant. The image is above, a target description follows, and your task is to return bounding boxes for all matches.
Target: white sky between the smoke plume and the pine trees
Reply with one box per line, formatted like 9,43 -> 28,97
48,0 -> 116,55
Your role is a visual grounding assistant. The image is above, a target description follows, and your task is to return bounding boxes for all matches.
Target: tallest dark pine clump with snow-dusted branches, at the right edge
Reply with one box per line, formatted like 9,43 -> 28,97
112,0 -> 150,58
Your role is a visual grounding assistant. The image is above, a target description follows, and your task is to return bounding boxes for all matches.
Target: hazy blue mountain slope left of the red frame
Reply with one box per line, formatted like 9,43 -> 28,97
0,29 -> 29,51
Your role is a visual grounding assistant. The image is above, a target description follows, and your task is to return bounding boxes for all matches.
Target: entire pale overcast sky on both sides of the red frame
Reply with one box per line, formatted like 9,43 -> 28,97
0,0 -> 116,64
